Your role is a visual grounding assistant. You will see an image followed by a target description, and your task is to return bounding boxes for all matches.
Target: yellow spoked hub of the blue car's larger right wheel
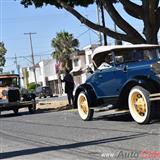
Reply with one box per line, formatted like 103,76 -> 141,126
131,92 -> 146,116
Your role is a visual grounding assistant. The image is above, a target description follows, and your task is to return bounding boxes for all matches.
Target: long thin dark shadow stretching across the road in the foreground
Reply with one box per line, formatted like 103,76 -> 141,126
0,133 -> 147,159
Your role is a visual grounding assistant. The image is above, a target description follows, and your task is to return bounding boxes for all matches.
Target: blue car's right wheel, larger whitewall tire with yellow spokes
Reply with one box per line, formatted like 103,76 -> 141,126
128,86 -> 152,124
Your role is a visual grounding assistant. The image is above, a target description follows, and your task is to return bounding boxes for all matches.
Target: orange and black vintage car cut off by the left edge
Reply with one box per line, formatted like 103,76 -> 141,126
0,74 -> 36,114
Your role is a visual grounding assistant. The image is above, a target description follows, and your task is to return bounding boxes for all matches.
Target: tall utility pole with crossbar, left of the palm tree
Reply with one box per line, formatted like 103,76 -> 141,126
24,32 -> 37,86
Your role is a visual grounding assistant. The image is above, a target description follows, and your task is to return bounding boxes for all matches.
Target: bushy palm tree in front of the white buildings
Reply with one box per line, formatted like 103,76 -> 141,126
51,31 -> 79,69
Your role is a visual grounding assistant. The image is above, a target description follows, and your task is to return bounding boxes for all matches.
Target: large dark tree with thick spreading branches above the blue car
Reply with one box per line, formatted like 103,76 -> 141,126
21,0 -> 160,44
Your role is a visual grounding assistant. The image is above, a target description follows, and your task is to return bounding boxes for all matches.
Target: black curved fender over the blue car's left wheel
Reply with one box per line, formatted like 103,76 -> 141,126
74,83 -> 97,108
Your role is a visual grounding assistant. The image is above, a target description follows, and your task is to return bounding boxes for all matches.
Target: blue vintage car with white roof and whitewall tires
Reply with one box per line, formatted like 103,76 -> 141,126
75,44 -> 160,124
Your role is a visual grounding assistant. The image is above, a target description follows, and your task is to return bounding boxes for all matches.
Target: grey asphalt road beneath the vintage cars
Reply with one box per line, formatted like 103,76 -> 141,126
0,107 -> 160,160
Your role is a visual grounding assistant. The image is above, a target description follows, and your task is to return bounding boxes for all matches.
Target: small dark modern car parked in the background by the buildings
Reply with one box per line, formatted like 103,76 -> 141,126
34,86 -> 53,98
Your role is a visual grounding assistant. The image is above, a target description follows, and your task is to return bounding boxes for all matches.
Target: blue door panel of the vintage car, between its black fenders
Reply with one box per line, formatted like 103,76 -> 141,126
91,55 -> 127,98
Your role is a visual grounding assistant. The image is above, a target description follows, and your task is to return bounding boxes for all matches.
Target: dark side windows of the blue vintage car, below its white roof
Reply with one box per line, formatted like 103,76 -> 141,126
115,48 -> 160,64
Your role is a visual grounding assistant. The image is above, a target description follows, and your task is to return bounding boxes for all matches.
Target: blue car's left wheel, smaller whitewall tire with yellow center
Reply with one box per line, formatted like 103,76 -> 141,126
77,92 -> 94,121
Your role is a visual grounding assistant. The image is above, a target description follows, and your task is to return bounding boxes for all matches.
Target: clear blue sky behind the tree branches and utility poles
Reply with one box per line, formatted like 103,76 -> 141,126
0,0 -> 159,71
